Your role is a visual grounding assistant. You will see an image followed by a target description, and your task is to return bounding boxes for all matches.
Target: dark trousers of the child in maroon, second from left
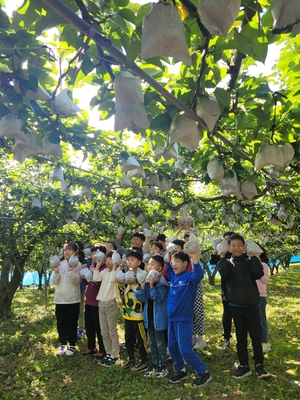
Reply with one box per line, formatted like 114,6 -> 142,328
84,304 -> 105,353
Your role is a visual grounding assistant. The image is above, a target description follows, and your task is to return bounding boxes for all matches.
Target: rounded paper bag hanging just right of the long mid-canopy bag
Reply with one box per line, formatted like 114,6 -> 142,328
169,114 -> 200,150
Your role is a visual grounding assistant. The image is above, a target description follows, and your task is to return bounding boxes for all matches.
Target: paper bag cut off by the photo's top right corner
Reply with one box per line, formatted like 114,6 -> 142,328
270,0 -> 300,33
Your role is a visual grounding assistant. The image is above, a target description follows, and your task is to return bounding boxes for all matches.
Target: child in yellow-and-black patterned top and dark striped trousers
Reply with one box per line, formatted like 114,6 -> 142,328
119,250 -> 147,371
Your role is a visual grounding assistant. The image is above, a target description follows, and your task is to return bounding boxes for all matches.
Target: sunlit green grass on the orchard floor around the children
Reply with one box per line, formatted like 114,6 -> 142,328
0,265 -> 300,400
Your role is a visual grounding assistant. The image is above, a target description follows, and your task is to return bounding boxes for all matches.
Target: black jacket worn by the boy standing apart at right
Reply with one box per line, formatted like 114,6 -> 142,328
218,255 -> 264,306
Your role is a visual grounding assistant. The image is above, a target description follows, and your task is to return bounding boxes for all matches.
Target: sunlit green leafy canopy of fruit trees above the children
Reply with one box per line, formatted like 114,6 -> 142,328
0,0 -> 300,312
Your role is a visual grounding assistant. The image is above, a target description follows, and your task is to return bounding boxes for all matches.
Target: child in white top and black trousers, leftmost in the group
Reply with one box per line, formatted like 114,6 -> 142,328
52,243 -> 81,356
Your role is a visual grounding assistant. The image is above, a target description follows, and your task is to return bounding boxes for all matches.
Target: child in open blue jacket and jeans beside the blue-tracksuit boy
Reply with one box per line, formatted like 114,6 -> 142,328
136,254 -> 169,378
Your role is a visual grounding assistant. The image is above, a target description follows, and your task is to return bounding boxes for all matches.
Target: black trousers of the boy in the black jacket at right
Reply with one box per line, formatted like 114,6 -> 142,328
231,306 -> 264,365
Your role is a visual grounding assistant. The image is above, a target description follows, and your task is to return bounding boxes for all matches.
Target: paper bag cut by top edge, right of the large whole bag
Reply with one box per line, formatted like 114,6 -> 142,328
198,0 -> 241,36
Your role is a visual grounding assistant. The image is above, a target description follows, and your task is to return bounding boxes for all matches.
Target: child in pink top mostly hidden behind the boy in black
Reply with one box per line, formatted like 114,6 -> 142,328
256,244 -> 271,353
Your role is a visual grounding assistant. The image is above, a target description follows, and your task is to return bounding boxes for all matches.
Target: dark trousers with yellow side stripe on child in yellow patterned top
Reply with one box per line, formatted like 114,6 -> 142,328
124,319 -> 148,362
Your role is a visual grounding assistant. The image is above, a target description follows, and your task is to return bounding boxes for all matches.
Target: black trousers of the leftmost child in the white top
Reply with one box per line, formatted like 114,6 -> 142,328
55,303 -> 80,346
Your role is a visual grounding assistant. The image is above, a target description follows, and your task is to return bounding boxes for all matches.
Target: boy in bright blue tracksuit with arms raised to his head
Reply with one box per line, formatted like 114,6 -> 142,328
167,251 -> 212,386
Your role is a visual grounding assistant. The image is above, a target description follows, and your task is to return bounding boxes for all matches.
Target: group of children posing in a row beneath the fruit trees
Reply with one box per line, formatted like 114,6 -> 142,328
53,233 -> 269,386
